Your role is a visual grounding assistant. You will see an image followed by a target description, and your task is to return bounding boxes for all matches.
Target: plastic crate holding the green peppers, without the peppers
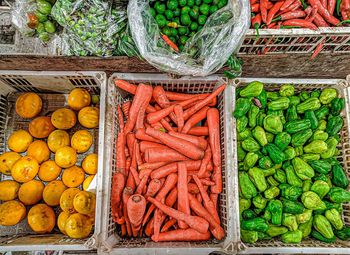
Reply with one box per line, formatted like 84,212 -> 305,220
232,78 -> 350,254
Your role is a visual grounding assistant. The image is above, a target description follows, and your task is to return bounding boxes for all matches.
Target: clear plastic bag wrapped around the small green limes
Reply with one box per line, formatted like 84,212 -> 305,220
128,0 -> 250,76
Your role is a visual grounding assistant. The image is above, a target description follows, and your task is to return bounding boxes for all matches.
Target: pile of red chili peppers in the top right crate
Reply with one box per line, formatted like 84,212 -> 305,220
250,0 -> 350,31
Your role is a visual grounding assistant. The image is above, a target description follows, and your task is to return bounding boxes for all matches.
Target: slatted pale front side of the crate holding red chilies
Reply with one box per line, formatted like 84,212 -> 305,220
239,27 -> 350,55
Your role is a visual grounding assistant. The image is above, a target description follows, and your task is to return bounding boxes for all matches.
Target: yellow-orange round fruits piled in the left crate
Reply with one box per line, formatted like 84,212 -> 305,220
0,88 -> 99,238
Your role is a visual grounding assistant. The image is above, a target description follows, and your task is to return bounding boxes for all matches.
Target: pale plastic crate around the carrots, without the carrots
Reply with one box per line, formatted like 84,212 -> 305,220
99,74 -> 237,254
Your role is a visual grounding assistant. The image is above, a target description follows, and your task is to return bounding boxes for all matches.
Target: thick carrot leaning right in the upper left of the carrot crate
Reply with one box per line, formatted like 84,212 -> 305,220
125,83 -> 153,133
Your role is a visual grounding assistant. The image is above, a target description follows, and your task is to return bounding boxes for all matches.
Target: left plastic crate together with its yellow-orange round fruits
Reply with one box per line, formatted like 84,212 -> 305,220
0,71 -> 106,252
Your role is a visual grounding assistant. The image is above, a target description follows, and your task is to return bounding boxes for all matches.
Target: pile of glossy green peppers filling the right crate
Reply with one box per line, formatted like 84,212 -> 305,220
233,81 -> 350,244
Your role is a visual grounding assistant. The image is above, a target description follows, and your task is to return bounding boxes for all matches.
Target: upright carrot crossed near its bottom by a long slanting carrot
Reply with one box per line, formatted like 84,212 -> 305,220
177,162 -> 191,228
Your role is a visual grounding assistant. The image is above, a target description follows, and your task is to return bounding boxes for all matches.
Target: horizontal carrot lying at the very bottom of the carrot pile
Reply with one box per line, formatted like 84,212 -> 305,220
151,228 -> 210,242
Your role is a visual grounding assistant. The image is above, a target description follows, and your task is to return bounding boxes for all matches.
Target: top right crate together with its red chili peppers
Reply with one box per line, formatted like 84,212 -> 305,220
239,0 -> 350,55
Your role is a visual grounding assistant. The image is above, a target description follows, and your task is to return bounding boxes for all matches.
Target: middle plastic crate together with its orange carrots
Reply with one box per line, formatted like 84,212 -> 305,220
97,74 -> 234,254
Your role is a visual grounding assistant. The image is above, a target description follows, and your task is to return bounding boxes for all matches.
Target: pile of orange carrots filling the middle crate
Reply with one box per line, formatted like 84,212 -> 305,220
111,80 -> 226,242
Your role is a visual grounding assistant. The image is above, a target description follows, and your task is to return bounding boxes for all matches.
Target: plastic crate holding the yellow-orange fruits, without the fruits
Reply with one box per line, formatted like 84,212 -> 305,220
0,71 -> 106,252
